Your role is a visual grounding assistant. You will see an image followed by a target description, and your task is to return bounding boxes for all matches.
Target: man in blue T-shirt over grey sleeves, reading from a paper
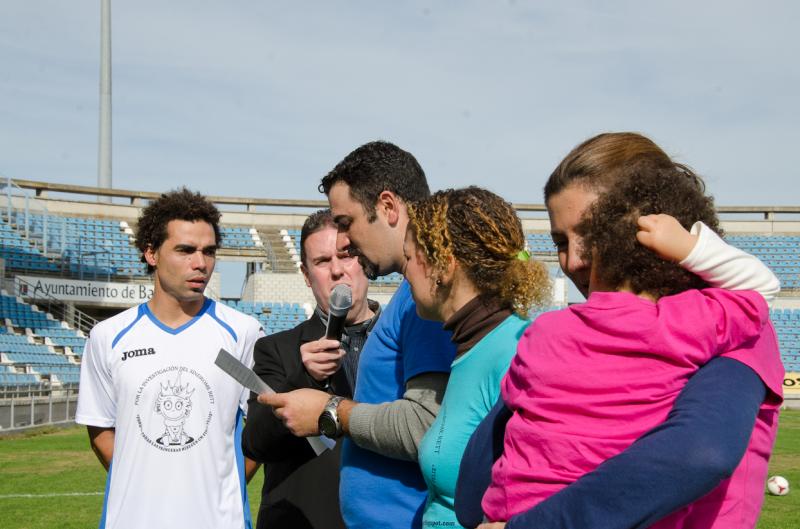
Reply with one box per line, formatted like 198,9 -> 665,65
259,142 -> 455,529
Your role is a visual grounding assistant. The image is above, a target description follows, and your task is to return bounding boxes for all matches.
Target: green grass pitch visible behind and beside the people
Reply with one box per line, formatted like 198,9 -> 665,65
0,411 -> 800,529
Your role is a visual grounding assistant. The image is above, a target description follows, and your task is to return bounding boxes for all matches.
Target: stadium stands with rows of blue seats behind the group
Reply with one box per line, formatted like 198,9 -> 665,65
0,177 -> 800,408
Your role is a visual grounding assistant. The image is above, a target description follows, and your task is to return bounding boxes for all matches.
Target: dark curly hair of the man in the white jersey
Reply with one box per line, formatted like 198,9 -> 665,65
136,187 -> 222,274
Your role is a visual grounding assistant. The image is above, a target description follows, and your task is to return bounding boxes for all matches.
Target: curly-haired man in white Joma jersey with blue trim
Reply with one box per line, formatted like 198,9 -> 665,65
75,188 -> 263,529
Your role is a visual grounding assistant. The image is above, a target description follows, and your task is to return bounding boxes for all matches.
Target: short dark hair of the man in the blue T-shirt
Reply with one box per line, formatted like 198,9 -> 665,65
319,141 -> 431,222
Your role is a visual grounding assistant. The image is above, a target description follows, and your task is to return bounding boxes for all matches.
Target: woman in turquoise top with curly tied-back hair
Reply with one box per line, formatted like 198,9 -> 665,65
403,187 -> 550,527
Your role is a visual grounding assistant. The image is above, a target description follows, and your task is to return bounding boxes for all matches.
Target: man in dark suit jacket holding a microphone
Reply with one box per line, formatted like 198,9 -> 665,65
242,210 -> 380,529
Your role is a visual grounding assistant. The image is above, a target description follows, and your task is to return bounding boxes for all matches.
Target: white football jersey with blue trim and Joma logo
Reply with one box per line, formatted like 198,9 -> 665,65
75,299 -> 264,529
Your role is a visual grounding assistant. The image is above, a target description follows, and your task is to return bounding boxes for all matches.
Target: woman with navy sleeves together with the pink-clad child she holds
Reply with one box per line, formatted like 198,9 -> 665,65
457,133 -> 782,527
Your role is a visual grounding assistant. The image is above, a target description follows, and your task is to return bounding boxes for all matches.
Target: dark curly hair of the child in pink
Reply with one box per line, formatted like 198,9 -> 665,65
575,157 -> 722,298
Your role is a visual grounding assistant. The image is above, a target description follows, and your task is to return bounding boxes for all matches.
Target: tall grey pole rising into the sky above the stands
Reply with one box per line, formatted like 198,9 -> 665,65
97,0 -> 111,202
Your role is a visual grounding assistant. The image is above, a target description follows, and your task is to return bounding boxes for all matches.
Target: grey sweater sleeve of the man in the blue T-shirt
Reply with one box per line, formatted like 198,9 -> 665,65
349,373 -> 449,461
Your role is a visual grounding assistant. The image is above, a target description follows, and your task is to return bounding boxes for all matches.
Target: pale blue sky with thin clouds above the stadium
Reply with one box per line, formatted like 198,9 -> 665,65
0,0 -> 800,209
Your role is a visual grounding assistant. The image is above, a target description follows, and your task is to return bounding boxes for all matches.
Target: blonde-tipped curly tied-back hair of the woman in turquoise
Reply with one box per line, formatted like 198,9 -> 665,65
408,186 -> 551,316
